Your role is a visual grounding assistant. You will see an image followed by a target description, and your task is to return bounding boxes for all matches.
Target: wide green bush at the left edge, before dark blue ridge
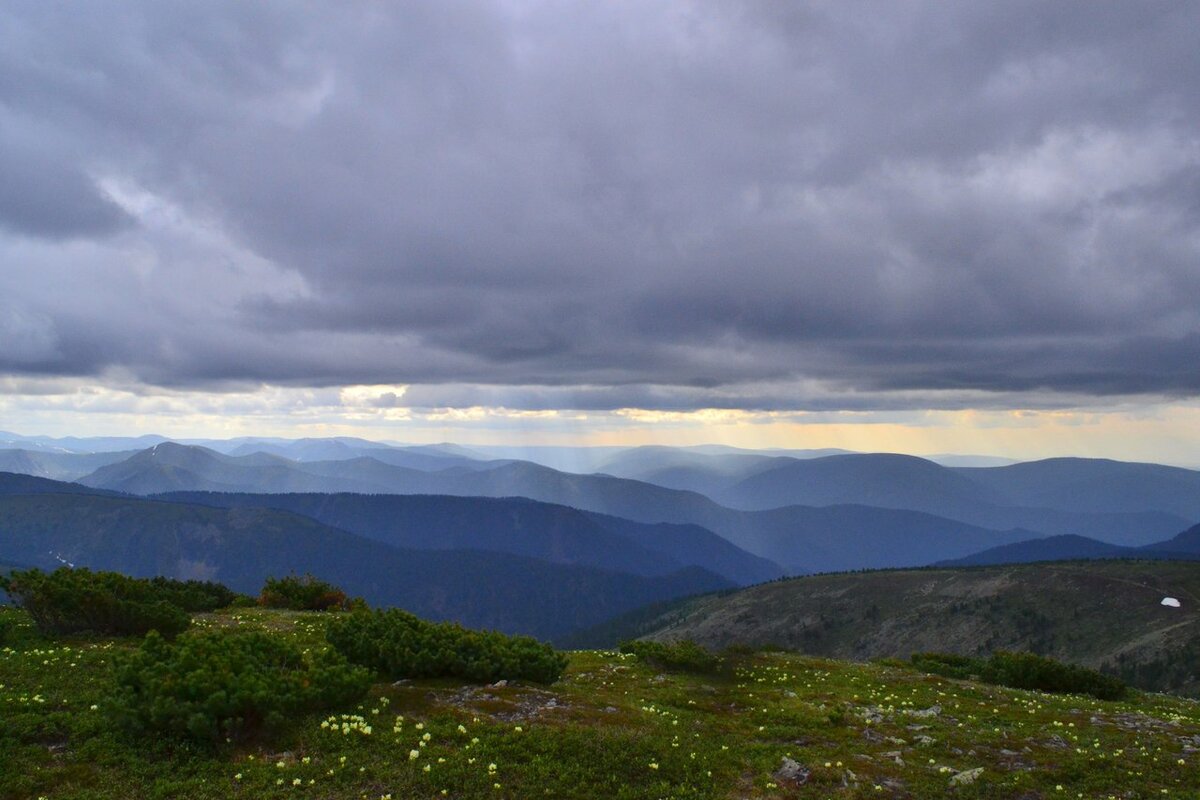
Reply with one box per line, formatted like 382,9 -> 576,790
0,567 -> 236,637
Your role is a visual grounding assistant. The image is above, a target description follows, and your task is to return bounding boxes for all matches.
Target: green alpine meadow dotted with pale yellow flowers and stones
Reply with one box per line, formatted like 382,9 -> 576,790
0,609 -> 1200,800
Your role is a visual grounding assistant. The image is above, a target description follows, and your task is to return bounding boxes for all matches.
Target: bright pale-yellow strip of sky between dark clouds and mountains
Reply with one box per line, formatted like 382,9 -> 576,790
0,386 -> 1200,468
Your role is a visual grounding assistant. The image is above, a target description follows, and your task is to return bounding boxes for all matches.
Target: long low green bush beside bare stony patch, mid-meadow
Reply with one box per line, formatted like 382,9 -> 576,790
325,608 -> 566,684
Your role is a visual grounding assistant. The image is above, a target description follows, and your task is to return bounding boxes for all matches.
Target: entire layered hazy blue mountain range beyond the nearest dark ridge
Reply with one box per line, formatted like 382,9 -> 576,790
0,434 -> 1200,584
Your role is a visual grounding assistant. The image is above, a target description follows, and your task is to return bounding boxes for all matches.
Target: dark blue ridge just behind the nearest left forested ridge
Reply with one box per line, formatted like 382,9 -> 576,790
160,492 -> 784,585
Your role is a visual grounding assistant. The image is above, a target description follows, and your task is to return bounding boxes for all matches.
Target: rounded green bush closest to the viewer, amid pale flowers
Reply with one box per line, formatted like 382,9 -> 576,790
112,631 -> 371,745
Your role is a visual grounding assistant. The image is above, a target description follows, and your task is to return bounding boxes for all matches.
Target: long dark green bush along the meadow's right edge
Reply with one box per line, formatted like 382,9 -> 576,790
912,650 -> 1128,700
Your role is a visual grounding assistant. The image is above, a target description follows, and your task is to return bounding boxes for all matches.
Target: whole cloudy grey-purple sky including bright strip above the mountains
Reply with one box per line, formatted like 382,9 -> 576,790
0,0 -> 1200,464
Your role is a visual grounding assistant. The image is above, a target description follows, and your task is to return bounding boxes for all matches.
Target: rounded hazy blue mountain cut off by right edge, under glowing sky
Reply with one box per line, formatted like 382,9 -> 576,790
954,458 -> 1200,523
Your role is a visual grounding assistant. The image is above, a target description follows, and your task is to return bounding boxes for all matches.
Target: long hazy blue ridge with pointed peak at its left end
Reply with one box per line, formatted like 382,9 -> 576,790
84,445 -> 1046,573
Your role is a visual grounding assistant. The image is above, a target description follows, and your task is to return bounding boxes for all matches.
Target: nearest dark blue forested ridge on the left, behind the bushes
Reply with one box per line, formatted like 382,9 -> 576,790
0,484 -> 732,638
